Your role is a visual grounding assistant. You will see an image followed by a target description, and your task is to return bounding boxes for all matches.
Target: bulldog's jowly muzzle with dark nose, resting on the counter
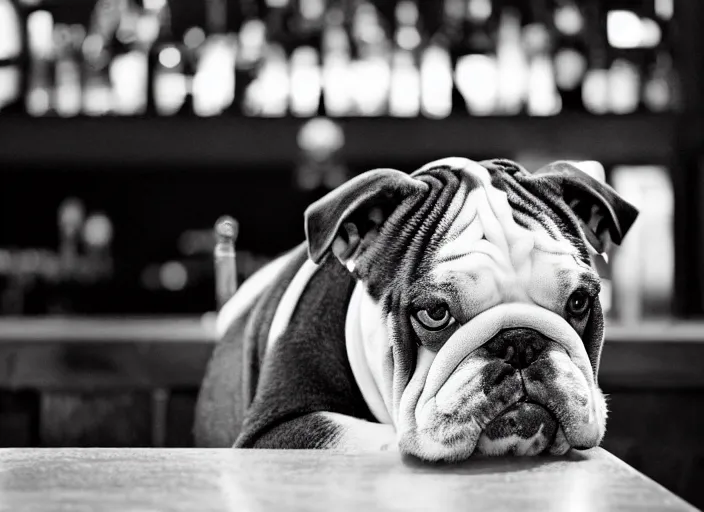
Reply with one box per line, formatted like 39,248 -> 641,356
397,304 -> 606,460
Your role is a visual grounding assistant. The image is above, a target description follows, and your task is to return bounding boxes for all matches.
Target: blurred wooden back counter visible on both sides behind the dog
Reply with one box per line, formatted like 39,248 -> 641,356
0,314 -> 704,390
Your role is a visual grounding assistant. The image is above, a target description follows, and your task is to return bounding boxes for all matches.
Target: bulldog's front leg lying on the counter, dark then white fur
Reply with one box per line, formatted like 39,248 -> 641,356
234,412 -> 397,452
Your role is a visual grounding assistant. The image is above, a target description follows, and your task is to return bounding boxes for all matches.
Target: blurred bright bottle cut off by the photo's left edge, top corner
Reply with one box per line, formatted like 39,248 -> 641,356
0,0 -> 25,112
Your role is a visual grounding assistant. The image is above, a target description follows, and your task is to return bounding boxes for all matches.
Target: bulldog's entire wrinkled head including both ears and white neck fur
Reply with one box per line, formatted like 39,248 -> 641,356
305,158 -> 637,461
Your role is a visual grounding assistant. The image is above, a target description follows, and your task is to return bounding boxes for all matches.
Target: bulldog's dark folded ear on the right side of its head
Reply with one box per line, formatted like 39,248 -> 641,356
533,161 -> 638,254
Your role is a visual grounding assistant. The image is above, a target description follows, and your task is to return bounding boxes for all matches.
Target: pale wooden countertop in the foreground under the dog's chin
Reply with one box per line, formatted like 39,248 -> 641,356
0,449 -> 696,512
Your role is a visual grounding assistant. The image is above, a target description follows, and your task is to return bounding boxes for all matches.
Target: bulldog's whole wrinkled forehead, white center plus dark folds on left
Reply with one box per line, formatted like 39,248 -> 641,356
369,157 -> 592,302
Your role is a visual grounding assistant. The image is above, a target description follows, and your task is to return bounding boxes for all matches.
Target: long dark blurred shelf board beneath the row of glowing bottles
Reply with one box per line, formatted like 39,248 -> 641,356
0,114 -> 676,166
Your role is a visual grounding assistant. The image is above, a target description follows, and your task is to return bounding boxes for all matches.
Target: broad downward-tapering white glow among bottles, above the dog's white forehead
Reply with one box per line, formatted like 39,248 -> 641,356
455,54 -> 498,116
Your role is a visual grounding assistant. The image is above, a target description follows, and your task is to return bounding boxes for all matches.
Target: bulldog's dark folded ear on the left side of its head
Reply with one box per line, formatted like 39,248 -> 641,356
305,169 -> 428,271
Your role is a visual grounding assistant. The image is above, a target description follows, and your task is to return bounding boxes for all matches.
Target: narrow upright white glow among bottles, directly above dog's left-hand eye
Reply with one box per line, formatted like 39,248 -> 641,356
420,45 -> 452,119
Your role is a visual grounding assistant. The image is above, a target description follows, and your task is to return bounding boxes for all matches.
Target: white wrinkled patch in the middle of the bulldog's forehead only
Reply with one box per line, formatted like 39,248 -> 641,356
415,158 -> 591,282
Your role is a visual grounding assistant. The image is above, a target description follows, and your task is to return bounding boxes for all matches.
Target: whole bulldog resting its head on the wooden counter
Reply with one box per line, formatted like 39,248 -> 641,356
195,158 -> 638,461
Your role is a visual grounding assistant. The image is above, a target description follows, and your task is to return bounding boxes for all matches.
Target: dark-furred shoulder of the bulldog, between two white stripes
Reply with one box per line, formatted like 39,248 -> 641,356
236,254 -> 373,447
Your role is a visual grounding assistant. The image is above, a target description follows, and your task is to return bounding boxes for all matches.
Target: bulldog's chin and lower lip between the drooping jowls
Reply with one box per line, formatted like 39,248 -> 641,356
475,401 -> 558,456
